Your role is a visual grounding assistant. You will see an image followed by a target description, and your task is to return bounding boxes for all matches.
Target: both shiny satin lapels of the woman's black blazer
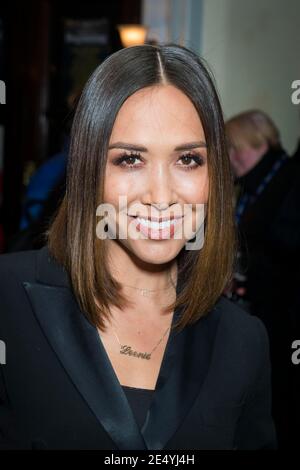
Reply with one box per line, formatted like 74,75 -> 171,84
23,247 -> 218,450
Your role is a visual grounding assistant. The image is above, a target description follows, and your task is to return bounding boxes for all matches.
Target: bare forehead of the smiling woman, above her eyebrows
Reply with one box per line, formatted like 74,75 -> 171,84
111,85 -> 204,143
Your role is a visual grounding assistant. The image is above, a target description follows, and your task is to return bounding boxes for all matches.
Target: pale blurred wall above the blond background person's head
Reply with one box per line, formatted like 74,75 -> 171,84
201,0 -> 300,151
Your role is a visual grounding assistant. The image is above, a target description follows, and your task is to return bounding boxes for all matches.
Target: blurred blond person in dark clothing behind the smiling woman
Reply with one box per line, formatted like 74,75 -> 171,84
226,110 -> 300,445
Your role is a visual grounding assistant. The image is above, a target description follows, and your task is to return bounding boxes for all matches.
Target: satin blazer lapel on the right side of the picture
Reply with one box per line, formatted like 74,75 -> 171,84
141,300 -> 219,450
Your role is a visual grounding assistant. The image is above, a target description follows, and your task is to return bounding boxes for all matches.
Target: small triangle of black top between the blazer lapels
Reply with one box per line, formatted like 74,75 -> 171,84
122,385 -> 154,428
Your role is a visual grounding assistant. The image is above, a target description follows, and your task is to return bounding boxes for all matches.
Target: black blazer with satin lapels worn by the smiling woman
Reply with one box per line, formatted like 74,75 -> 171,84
0,247 -> 276,450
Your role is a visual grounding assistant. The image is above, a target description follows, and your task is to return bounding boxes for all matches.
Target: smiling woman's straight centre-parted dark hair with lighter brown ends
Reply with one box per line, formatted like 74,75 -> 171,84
45,43 -> 236,331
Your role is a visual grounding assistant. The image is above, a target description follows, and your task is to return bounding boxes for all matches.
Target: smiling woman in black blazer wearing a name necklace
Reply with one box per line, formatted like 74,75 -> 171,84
0,44 -> 276,450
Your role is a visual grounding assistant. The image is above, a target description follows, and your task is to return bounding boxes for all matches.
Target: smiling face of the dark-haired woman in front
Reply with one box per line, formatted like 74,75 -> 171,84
104,85 -> 209,264
